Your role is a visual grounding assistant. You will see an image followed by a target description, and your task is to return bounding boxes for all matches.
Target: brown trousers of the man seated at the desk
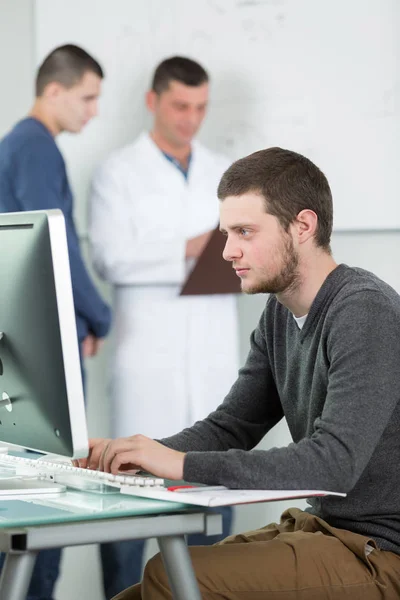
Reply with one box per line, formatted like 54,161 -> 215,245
114,508 -> 400,600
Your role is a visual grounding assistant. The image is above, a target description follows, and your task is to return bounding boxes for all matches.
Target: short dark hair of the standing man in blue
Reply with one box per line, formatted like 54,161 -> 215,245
36,44 -> 104,97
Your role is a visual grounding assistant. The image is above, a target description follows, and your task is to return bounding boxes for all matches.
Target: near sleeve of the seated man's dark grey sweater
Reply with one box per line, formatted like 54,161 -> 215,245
175,291 -> 400,492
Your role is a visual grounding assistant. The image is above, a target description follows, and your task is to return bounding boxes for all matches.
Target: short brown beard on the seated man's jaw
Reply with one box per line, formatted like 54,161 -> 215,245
243,235 -> 299,294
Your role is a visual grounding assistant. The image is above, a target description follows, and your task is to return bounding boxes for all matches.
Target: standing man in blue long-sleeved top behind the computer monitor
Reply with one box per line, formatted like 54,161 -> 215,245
0,45 -> 114,600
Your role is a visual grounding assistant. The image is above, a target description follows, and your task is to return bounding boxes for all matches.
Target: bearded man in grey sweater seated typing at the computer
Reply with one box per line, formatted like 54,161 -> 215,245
83,148 -> 400,600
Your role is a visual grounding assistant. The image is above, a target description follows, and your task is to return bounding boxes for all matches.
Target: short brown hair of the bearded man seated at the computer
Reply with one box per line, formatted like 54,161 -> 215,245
218,148 -> 333,252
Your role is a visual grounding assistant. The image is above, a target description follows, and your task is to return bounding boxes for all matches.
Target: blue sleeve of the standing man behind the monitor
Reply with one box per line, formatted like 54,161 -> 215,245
13,138 -> 111,337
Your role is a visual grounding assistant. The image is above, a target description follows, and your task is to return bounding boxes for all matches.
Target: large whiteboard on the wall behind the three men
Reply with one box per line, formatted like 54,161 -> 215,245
35,0 -> 400,233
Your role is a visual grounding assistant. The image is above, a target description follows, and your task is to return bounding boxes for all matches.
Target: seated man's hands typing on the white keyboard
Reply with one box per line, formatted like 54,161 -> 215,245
78,435 -> 185,479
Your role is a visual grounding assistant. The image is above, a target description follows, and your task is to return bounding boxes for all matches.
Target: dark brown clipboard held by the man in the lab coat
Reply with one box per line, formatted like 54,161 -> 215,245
179,227 -> 242,296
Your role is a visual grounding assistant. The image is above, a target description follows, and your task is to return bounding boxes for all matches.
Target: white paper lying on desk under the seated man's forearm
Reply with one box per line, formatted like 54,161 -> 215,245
117,485 -> 346,506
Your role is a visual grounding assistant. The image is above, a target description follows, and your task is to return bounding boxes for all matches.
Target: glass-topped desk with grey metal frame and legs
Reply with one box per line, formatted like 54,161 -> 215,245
0,491 -> 221,600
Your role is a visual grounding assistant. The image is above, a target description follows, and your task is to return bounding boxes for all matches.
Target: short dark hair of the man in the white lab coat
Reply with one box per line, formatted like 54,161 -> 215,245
151,56 -> 209,94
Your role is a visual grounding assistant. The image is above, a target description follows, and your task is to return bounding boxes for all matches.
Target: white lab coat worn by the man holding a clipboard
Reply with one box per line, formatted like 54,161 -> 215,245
89,133 -> 239,438
